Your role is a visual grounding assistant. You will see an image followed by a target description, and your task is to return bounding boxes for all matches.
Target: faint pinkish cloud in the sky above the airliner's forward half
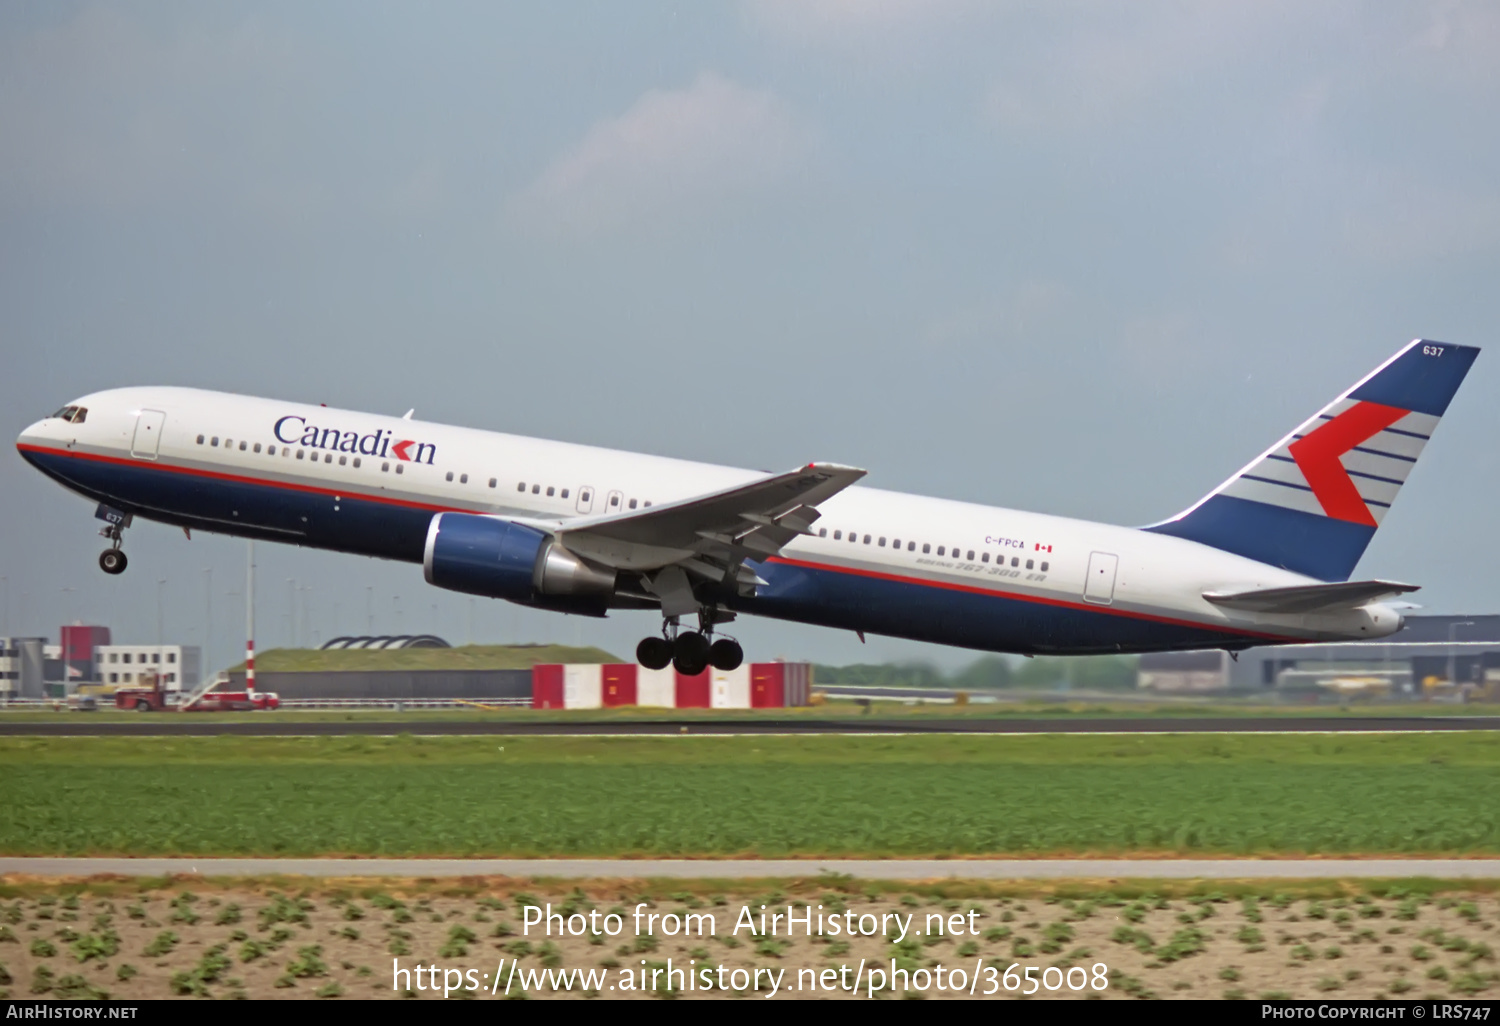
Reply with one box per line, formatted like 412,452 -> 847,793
509,74 -> 812,231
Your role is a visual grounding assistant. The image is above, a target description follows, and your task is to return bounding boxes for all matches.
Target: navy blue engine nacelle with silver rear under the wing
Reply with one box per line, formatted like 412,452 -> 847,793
422,513 -> 615,617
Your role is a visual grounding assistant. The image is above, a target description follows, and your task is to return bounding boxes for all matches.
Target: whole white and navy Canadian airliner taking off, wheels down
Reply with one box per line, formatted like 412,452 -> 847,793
17,339 -> 1479,674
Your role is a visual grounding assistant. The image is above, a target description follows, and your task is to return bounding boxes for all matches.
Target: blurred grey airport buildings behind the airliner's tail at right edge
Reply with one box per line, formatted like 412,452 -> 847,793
1139,615 -> 1500,701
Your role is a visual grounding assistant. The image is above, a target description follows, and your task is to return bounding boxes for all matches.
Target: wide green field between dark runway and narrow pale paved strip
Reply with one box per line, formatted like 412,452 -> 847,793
0,732 -> 1500,857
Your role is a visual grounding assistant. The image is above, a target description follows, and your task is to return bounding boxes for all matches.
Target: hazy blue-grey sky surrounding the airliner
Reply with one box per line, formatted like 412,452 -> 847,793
0,0 -> 1500,665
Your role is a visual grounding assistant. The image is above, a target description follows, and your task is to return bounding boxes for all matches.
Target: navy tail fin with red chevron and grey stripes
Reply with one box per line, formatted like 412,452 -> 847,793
1145,339 -> 1479,581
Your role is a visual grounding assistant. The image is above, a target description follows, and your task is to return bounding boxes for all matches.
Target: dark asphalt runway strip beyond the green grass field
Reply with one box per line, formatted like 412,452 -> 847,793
0,713 -> 1500,738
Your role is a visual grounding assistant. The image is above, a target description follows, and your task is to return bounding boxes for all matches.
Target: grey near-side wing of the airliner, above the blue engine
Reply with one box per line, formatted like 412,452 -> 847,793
552,464 -> 866,585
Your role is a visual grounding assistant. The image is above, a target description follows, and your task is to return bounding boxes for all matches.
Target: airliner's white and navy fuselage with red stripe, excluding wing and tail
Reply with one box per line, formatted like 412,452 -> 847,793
18,387 -> 1401,653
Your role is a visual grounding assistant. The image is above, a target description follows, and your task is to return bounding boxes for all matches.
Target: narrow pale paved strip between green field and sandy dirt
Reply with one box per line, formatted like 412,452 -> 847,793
0,858 -> 1500,881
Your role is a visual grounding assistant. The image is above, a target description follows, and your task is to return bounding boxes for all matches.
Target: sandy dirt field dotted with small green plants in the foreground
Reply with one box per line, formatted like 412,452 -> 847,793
0,881 -> 1500,1001
